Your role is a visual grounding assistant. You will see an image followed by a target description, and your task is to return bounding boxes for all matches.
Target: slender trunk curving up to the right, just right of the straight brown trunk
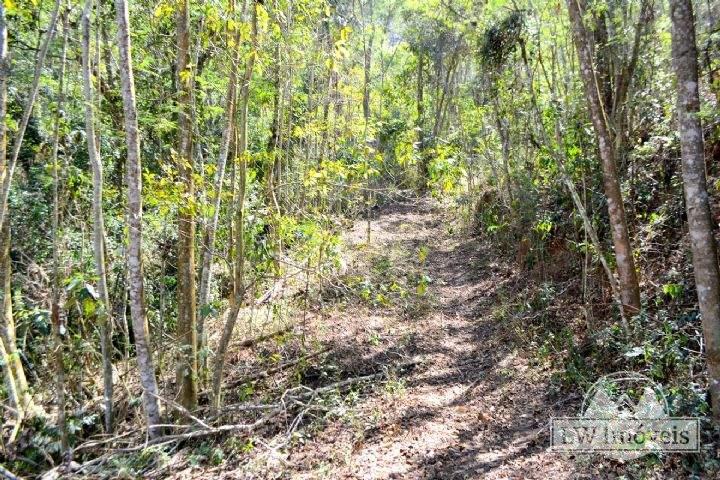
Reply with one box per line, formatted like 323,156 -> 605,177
211,0 -> 258,408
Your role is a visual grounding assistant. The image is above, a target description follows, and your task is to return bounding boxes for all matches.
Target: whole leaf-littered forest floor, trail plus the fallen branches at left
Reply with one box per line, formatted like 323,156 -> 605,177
69,199 -> 713,480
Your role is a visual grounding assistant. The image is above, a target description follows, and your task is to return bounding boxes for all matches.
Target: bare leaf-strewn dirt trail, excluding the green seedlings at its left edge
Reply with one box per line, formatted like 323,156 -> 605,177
283,201 -> 579,480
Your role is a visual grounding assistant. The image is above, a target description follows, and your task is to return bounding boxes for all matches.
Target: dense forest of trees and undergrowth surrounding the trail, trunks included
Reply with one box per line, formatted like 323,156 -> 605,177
0,0 -> 720,478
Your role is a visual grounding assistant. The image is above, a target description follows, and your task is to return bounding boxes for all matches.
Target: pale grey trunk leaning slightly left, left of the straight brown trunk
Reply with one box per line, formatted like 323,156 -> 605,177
115,0 -> 161,437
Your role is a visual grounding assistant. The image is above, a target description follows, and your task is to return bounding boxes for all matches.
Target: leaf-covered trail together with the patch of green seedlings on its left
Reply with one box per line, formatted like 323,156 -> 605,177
174,201 -> 587,479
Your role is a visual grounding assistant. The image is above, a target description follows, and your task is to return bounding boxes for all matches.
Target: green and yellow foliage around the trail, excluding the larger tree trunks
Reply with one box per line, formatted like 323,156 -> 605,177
0,0 -> 720,476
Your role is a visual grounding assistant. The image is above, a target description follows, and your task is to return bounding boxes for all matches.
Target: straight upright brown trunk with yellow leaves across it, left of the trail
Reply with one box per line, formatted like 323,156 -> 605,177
175,0 -> 198,410
